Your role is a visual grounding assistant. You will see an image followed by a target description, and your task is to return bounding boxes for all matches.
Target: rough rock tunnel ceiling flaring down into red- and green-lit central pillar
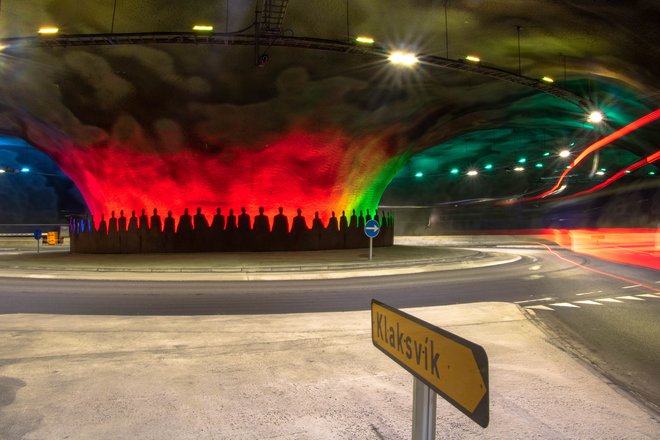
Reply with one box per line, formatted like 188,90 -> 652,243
0,0 -> 660,218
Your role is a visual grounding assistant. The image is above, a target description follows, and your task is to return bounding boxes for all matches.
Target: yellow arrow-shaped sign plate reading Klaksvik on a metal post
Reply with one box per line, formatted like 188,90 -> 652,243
371,300 -> 489,428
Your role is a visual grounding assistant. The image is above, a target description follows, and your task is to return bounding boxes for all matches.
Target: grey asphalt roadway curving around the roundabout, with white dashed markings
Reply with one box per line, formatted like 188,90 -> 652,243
0,247 -> 660,411
